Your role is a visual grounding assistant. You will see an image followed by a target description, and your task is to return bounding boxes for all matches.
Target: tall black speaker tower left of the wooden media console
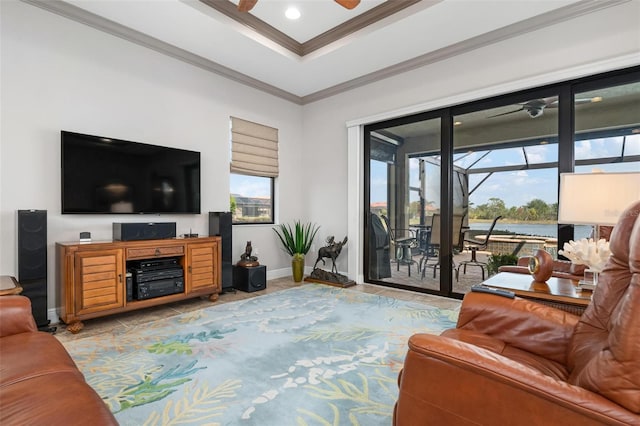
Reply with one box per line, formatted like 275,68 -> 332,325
18,210 -> 49,329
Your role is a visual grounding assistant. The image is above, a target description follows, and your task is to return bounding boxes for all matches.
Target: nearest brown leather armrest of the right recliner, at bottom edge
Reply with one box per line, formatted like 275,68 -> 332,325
394,334 -> 640,426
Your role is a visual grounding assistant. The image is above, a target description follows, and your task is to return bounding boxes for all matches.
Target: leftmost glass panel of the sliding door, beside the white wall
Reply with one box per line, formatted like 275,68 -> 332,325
365,117 -> 442,292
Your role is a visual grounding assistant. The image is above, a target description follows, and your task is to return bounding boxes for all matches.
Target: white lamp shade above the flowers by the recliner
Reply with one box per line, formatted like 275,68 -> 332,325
558,172 -> 640,225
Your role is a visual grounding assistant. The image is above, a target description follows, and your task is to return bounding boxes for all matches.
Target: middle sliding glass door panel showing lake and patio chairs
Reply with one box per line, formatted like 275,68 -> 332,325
453,92 -> 560,294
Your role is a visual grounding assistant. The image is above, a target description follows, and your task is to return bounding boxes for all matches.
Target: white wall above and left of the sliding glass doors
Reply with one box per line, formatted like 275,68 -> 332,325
303,1 -> 640,282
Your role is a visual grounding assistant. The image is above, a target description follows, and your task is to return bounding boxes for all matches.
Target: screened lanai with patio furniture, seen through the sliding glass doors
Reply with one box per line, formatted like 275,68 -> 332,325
365,73 -> 640,296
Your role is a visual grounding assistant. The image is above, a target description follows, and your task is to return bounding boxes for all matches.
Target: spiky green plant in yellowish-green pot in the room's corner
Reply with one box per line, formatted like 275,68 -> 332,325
273,220 -> 319,282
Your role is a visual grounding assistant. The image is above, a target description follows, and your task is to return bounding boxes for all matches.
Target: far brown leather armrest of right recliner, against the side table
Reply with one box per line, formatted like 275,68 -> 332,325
457,292 -> 580,364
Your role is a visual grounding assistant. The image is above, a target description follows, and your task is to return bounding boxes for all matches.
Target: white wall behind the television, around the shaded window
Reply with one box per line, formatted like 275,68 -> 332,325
0,1 -> 304,308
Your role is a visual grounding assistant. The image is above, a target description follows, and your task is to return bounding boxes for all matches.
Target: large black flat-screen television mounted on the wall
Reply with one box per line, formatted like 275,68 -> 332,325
61,131 -> 200,214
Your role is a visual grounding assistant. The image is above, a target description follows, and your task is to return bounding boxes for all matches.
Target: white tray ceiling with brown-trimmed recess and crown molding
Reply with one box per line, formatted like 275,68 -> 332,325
23,0 -> 625,104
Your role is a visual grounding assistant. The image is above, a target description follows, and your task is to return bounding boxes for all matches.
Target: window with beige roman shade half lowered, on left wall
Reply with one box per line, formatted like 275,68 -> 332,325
230,117 -> 278,224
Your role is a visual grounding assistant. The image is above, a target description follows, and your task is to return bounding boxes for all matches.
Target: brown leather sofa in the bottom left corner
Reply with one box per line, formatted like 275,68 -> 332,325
0,296 -> 118,426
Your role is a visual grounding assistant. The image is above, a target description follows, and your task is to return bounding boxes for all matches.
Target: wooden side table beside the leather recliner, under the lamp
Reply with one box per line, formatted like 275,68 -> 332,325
482,272 -> 592,315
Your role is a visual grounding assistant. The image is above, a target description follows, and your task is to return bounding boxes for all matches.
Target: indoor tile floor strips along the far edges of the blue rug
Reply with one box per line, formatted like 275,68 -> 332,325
55,278 -> 460,342
